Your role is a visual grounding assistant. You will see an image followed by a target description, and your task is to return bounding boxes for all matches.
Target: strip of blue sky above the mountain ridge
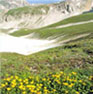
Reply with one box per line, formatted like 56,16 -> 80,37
27,0 -> 62,4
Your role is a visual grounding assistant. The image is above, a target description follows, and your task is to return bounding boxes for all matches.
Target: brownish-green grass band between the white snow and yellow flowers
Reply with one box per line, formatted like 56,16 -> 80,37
1,35 -> 93,77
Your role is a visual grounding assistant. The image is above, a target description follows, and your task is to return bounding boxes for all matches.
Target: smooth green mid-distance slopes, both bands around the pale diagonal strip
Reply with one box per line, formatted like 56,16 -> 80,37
11,13 -> 93,38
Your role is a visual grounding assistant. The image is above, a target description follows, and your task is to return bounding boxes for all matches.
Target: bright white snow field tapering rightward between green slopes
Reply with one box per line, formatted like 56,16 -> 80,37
0,33 -> 58,55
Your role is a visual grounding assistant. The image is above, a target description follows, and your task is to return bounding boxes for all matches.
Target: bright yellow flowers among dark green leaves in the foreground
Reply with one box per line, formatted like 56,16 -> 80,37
1,72 -> 93,94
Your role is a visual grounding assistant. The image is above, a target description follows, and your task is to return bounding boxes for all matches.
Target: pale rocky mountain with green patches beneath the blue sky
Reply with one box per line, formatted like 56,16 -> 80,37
0,0 -> 93,29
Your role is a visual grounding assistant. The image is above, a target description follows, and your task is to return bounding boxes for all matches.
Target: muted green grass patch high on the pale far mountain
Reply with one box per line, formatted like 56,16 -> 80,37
6,5 -> 49,17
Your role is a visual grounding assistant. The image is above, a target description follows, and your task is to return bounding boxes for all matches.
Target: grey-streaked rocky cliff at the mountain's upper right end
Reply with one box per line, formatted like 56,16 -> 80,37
57,0 -> 93,13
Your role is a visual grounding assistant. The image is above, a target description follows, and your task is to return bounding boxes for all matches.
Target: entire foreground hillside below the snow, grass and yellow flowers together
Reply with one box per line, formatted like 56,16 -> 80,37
1,34 -> 93,94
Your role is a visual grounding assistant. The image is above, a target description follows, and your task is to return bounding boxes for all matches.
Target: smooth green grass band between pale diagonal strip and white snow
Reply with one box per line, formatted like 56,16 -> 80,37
11,23 -> 93,39
